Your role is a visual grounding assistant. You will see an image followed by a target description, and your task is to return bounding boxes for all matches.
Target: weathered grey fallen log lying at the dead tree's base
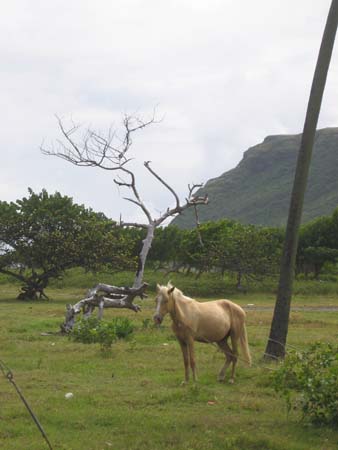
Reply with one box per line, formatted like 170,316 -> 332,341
60,283 -> 148,334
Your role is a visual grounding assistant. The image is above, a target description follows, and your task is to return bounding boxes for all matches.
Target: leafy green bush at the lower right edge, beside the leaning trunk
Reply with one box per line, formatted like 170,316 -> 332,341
274,343 -> 338,427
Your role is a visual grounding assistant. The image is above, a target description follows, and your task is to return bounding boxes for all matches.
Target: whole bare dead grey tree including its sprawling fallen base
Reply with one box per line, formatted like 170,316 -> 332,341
41,115 -> 208,332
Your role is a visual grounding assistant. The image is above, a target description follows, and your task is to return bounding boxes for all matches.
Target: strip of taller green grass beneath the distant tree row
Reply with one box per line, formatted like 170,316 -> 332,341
0,268 -> 338,304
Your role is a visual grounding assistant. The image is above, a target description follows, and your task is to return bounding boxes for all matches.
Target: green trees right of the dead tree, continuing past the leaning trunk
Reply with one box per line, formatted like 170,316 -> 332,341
149,208 -> 338,287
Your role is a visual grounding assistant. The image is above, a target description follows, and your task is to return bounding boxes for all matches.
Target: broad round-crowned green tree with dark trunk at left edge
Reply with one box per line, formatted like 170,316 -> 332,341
0,189 -> 131,299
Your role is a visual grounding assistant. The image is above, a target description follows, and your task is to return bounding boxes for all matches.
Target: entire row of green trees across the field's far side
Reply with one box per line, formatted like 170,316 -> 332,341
0,190 -> 338,299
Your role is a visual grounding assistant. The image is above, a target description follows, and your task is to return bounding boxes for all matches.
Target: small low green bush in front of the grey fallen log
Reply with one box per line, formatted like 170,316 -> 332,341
70,317 -> 134,350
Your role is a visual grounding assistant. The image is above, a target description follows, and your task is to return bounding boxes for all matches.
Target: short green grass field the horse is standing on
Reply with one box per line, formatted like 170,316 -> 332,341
0,274 -> 338,450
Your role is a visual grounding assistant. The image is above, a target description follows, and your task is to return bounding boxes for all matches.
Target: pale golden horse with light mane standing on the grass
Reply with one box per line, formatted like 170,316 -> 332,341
154,283 -> 251,383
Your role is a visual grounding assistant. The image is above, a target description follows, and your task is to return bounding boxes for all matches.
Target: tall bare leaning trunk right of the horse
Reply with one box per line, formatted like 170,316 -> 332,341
265,0 -> 338,359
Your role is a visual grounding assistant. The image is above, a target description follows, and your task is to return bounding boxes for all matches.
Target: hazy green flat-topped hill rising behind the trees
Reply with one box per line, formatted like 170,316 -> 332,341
172,128 -> 338,228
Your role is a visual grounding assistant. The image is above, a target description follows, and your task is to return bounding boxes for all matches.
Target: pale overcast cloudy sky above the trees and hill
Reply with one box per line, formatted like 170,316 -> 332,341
0,0 -> 338,221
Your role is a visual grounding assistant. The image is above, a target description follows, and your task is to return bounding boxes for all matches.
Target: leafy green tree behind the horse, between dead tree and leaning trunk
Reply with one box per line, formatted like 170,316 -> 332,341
169,219 -> 283,288
